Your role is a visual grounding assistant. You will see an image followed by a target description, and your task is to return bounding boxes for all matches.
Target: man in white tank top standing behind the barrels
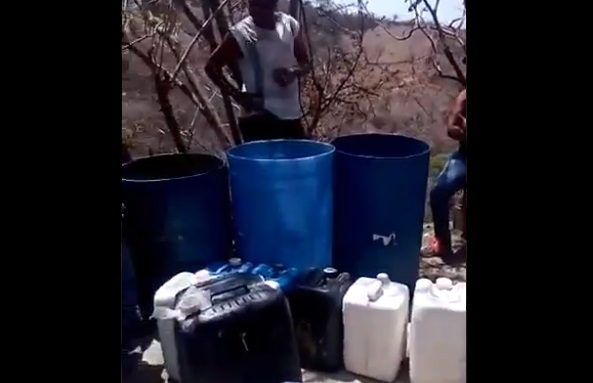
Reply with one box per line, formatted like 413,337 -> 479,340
205,0 -> 309,142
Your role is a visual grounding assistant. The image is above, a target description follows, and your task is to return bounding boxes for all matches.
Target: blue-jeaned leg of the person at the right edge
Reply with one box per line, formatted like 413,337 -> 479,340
430,152 -> 467,255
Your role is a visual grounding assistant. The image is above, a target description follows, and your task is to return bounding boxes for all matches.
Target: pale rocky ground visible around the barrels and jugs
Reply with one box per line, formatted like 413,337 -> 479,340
123,224 -> 466,383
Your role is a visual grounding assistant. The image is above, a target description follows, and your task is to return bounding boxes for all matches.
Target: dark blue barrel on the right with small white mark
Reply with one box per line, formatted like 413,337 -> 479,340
332,134 -> 430,291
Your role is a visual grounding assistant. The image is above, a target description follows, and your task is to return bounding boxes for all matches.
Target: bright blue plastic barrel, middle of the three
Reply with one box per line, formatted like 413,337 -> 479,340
227,140 -> 335,269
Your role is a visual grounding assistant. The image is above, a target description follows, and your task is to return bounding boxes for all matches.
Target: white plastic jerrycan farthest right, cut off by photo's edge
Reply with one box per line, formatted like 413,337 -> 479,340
408,278 -> 467,383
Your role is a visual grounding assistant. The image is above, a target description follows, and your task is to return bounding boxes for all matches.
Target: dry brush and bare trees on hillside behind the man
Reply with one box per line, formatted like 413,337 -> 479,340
122,0 -> 465,155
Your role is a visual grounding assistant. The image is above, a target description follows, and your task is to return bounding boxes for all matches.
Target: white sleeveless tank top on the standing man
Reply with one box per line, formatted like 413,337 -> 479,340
231,12 -> 302,120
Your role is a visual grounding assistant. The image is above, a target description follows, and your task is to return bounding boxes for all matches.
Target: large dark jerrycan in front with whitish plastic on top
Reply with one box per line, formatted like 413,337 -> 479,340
175,273 -> 302,383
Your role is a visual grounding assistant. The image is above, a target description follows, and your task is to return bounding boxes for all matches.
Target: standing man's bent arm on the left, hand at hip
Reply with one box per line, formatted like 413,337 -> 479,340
204,33 -> 243,104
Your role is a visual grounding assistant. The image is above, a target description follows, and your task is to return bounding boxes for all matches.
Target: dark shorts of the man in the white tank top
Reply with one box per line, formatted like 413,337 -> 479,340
239,113 -> 307,142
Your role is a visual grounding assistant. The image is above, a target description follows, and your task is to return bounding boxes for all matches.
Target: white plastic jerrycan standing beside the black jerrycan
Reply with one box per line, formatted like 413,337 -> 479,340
344,273 -> 410,382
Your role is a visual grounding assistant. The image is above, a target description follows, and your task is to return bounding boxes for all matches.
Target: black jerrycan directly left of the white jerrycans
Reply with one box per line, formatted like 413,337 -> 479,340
287,267 -> 352,372
